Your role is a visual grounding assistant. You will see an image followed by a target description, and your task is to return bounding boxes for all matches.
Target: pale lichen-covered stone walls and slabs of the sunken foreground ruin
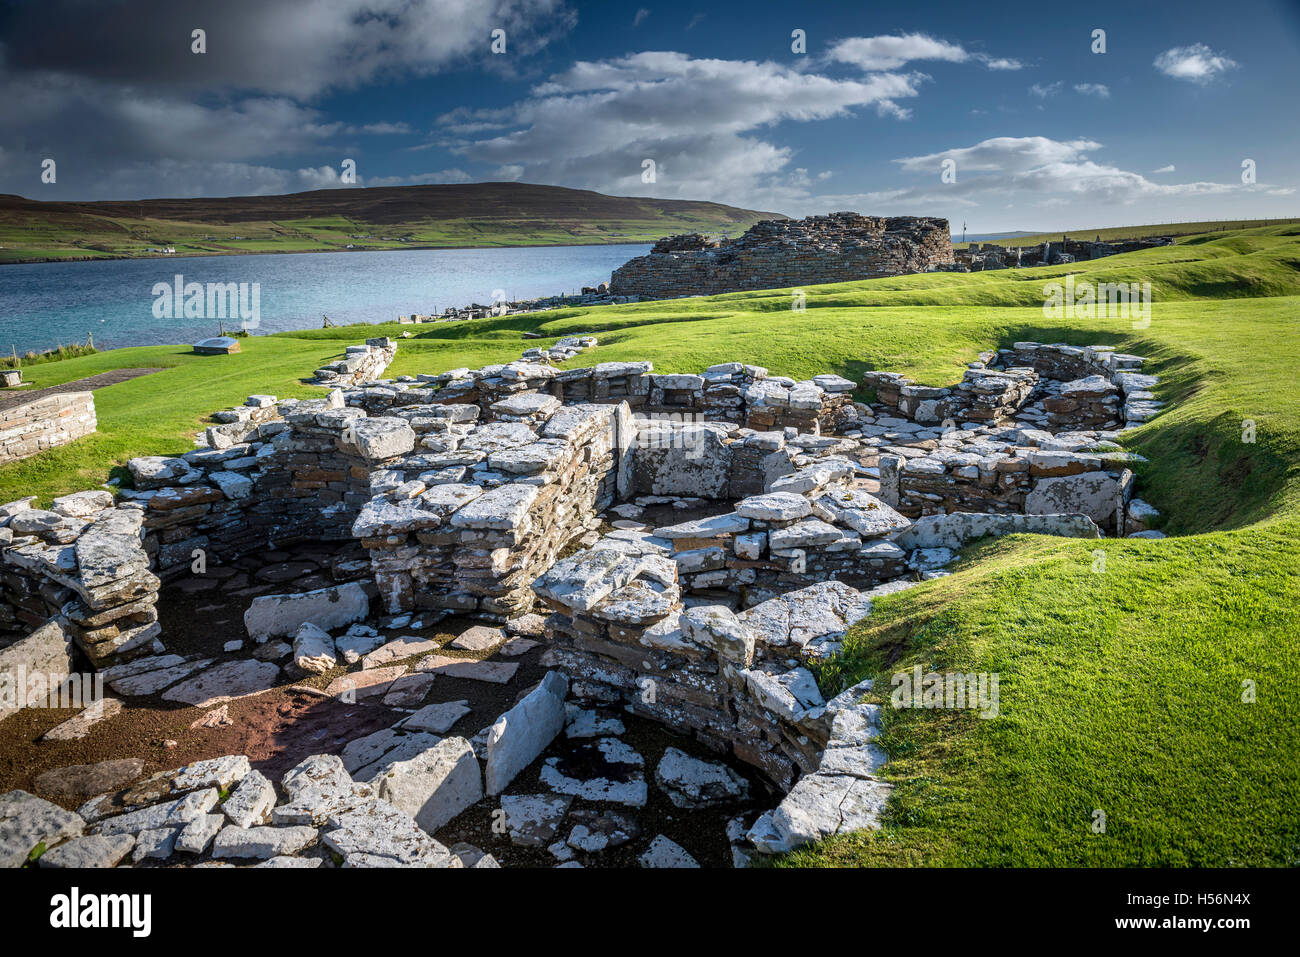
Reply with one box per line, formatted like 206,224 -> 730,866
0,330 -> 1161,867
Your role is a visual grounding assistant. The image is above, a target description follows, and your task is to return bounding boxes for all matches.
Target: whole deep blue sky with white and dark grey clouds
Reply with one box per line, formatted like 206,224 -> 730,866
0,0 -> 1300,234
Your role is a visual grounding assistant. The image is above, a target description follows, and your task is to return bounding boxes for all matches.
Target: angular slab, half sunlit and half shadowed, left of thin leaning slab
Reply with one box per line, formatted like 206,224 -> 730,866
373,737 -> 484,833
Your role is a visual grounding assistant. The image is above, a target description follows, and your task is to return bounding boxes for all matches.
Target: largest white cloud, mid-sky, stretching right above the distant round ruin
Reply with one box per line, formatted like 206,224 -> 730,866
439,51 -> 924,208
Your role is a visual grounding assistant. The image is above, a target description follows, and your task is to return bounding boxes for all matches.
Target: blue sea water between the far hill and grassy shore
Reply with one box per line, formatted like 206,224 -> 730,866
0,244 -> 650,354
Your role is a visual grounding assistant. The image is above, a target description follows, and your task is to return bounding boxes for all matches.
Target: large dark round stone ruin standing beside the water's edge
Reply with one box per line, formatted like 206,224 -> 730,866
610,212 -> 953,299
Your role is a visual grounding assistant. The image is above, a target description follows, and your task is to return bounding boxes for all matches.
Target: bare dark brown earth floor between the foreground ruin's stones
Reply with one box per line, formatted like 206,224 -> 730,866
0,538 -> 779,867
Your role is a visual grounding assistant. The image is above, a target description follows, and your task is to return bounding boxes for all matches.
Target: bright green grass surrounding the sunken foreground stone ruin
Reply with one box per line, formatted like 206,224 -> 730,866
0,225 -> 1300,866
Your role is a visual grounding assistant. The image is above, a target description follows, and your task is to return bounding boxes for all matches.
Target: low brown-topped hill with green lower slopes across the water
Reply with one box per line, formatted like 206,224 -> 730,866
0,183 -> 785,263
